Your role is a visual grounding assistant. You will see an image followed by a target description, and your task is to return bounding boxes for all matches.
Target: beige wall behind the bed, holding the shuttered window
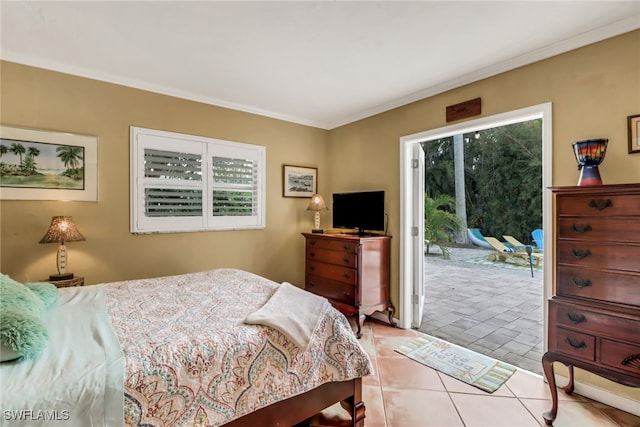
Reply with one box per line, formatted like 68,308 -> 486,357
0,62 -> 328,285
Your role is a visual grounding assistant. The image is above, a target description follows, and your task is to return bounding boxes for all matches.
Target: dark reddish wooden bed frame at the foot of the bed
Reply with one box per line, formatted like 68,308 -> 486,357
225,378 -> 365,427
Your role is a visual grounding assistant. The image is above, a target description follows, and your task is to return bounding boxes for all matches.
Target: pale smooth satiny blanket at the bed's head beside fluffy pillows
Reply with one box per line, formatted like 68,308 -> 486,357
0,285 -> 124,427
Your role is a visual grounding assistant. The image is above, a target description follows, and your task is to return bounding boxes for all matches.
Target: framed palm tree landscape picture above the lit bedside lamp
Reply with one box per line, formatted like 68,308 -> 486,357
0,126 -> 98,201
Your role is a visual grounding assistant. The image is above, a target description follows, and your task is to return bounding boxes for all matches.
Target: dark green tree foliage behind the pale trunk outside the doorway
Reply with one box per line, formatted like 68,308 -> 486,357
422,119 -> 542,243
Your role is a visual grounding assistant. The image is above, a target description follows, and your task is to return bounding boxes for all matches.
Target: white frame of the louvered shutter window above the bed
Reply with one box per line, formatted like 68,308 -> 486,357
130,126 -> 266,234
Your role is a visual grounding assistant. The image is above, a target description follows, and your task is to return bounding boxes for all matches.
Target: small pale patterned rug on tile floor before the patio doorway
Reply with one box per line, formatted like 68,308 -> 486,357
396,334 -> 516,393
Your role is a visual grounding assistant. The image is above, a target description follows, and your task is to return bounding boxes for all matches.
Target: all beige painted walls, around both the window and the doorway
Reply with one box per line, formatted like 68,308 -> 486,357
0,31 -> 640,400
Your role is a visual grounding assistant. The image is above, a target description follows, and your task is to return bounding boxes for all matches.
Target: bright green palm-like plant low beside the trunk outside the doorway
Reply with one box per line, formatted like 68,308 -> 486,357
424,194 -> 462,258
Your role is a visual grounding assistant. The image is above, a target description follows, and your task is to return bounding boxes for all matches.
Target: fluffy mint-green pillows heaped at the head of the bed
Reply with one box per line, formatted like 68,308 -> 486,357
0,274 -> 51,362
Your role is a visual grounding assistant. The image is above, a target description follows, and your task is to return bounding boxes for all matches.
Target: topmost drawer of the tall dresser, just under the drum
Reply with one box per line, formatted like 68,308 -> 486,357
557,194 -> 640,217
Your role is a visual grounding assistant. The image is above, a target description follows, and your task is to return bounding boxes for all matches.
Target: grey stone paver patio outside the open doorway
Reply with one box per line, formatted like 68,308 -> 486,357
419,248 -> 543,374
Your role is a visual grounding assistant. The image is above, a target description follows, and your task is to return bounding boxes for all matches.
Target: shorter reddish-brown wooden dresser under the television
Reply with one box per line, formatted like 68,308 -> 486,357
303,233 -> 395,338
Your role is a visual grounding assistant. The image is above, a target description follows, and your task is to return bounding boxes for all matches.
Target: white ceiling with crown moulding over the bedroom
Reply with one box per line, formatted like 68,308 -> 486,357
0,0 -> 640,129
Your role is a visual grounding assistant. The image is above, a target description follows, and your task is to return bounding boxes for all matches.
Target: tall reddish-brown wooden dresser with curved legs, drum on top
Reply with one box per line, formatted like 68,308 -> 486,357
542,184 -> 640,425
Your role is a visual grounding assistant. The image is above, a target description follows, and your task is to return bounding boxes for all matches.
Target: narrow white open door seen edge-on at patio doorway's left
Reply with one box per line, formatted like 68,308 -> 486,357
411,143 -> 424,328
